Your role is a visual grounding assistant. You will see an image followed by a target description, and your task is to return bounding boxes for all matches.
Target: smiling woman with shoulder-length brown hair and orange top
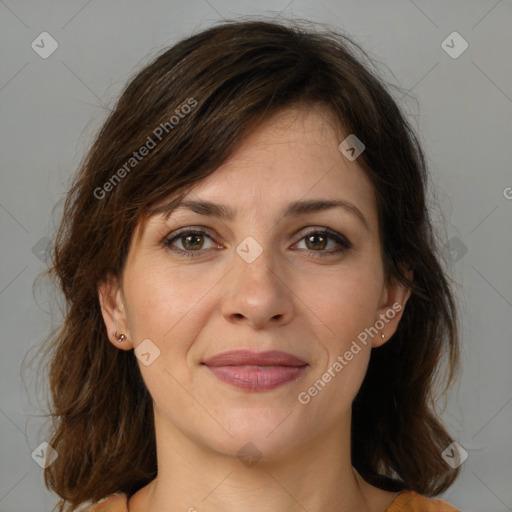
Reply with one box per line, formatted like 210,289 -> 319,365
40,20 -> 458,512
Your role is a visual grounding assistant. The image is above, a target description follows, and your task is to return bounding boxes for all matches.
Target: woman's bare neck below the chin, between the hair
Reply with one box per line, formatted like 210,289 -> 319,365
134,411 -> 371,512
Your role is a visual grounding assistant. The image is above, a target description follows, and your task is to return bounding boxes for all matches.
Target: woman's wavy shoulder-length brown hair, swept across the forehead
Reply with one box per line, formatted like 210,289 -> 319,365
34,19 -> 459,511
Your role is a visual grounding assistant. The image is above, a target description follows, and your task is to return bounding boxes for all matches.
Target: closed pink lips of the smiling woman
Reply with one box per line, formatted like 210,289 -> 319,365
202,350 -> 308,391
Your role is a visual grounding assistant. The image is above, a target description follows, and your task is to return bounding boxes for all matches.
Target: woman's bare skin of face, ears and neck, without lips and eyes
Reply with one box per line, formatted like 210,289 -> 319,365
98,107 -> 409,512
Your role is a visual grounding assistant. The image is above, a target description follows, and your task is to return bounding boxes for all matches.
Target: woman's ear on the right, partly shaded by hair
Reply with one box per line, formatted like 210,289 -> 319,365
372,269 -> 413,347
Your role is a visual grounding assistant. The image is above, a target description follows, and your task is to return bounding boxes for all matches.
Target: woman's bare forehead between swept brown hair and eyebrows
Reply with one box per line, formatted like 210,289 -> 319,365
176,107 -> 373,204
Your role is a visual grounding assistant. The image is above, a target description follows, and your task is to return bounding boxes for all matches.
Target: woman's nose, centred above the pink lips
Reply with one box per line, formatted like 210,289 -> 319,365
222,242 -> 295,330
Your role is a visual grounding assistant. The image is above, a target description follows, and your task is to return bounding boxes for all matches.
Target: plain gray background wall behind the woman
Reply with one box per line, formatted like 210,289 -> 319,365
0,0 -> 512,512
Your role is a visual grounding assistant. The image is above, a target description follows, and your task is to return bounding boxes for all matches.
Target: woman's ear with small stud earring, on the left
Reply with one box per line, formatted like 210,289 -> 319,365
98,276 -> 134,350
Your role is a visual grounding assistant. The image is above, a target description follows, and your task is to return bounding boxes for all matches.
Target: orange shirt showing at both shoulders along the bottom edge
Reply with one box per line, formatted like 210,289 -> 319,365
83,491 -> 460,512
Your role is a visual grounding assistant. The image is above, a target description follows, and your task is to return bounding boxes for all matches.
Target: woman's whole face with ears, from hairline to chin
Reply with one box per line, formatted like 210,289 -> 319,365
99,107 -> 408,457
